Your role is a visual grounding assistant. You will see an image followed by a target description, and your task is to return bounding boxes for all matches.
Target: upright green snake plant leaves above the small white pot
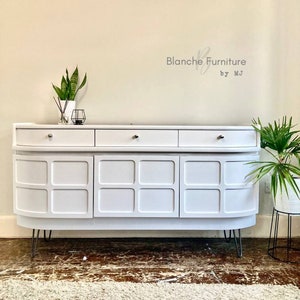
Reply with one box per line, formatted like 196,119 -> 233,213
52,67 -> 87,101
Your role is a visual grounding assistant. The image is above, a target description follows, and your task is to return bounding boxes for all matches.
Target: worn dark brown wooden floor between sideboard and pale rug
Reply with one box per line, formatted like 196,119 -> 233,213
0,238 -> 300,287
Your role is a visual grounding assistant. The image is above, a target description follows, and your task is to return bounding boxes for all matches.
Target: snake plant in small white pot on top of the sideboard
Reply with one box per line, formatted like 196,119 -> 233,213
52,67 -> 87,124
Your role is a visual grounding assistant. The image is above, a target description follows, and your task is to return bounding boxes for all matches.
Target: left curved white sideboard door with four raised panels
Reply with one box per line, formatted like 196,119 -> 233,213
14,155 -> 93,218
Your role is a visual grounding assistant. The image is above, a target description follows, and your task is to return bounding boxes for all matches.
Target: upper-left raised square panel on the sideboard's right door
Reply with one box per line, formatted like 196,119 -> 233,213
184,161 -> 221,185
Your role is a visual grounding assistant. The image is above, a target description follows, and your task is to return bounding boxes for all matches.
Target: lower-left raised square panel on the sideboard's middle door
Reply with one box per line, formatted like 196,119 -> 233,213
98,188 -> 134,213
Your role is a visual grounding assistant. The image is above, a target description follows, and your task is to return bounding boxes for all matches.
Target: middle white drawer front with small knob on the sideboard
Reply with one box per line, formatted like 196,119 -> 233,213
96,129 -> 178,147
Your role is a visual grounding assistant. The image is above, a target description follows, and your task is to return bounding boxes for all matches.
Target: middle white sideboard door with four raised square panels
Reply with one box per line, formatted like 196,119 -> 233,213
94,155 -> 179,217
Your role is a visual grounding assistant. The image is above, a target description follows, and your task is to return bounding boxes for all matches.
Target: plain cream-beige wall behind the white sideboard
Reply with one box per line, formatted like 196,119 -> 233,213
0,0 -> 300,236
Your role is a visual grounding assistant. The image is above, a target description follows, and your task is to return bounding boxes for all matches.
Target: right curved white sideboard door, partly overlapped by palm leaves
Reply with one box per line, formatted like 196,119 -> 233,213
180,154 -> 258,218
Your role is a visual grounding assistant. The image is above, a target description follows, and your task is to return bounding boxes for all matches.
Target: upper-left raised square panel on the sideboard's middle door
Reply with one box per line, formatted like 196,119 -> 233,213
98,160 -> 135,184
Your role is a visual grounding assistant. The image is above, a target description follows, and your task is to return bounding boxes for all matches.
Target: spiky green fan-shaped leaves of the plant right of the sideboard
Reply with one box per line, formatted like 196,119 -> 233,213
247,116 -> 300,201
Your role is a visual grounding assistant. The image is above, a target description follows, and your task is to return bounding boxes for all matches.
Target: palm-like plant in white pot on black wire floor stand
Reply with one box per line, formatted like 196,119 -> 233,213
247,117 -> 300,262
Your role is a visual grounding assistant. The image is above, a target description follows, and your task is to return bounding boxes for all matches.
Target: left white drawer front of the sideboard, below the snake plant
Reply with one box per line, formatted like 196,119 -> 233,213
16,129 -> 94,147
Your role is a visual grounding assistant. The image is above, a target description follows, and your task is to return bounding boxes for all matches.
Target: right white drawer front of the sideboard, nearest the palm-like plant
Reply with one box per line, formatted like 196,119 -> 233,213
179,130 -> 257,147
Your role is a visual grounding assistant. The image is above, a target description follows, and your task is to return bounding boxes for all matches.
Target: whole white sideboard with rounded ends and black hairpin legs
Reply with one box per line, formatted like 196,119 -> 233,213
13,124 -> 260,256
